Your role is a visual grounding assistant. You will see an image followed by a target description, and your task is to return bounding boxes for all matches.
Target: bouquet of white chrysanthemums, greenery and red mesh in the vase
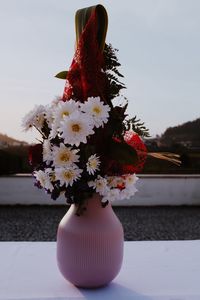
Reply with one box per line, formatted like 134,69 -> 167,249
23,7 -> 148,215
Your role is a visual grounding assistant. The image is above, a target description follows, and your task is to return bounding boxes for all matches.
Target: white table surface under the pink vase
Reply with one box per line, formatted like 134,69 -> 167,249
0,241 -> 200,300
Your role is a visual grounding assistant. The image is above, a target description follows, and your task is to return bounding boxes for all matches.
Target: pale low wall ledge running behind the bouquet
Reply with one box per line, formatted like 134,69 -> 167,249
0,174 -> 200,206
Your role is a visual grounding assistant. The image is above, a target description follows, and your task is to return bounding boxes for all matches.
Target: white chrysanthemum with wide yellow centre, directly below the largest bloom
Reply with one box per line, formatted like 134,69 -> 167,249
53,144 -> 79,167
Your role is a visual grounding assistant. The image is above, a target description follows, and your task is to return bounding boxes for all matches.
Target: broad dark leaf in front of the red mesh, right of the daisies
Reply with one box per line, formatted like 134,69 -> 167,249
108,140 -> 138,165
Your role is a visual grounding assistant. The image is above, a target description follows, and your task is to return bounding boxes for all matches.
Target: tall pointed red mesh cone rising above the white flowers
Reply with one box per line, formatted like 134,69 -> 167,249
63,11 -> 106,102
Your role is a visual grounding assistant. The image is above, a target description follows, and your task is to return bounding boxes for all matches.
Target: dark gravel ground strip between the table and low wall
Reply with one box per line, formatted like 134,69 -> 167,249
0,205 -> 200,241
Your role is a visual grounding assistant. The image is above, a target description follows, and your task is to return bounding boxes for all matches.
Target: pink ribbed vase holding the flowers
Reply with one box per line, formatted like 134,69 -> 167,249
57,194 -> 124,288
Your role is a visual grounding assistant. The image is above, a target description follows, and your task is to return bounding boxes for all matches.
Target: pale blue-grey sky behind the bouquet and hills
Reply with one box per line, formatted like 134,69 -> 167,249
0,0 -> 200,142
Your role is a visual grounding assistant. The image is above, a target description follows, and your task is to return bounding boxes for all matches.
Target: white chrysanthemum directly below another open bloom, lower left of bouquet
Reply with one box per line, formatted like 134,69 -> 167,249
55,167 -> 82,187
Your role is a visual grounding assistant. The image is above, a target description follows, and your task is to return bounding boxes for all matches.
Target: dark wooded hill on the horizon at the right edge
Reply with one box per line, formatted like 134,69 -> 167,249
160,118 -> 200,147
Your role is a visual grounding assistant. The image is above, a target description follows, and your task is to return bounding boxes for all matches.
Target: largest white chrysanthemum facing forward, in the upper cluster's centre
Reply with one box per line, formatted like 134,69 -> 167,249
60,112 -> 94,147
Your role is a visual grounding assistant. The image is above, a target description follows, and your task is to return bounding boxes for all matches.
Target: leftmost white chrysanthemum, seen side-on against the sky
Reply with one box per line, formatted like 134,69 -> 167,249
22,105 -> 46,131
